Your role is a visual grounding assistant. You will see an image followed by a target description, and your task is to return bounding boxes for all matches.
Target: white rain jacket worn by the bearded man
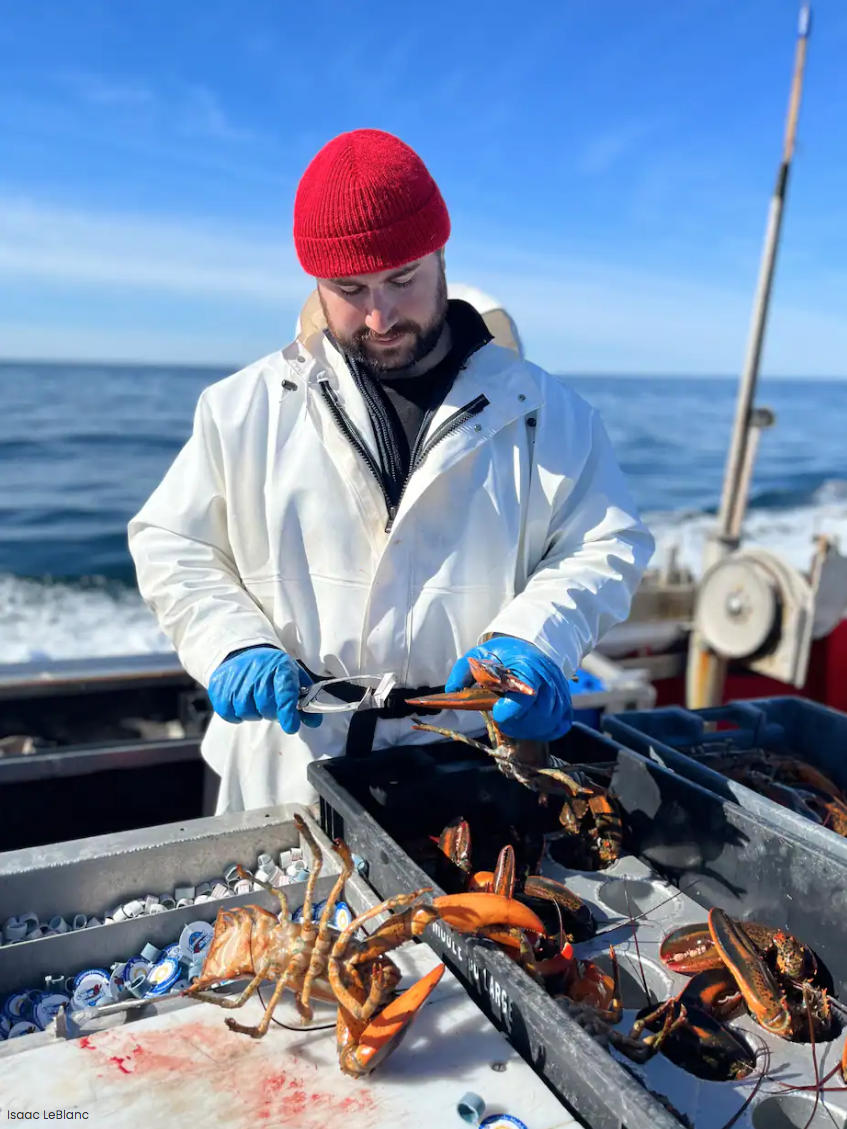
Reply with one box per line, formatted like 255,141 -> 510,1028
129,288 -> 654,813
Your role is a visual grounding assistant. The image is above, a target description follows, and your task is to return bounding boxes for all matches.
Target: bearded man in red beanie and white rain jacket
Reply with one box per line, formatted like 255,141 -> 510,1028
129,130 -> 654,812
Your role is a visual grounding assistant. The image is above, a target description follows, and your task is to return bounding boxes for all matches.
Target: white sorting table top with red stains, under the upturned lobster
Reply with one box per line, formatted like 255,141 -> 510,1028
0,945 -> 578,1129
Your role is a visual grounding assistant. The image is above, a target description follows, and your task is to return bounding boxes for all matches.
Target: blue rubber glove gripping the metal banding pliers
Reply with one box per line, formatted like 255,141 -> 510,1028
209,647 -> 322,734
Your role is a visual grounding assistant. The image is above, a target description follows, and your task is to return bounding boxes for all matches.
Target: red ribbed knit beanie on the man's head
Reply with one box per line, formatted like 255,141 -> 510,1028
294,130 -> 449,279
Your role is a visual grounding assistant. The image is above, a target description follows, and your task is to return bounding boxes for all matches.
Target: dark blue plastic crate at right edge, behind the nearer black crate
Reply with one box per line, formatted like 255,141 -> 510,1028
602,698 -> 847,864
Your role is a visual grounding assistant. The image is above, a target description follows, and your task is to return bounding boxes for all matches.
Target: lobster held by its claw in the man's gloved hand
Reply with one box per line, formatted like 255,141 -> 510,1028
407,658 -> 622,865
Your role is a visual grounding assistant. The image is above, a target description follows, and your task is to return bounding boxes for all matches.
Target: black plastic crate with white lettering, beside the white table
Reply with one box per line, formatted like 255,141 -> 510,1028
308,724 -> 847,1129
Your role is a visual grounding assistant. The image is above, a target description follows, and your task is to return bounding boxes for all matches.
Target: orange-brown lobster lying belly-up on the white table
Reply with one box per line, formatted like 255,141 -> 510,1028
183,815 -> 543,1078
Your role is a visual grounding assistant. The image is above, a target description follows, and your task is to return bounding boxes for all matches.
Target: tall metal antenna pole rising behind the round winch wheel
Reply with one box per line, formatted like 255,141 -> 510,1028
687,3 -> 812,709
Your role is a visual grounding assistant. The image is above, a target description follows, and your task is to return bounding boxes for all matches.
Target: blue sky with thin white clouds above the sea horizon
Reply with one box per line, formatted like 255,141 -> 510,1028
0,0 -> 847,376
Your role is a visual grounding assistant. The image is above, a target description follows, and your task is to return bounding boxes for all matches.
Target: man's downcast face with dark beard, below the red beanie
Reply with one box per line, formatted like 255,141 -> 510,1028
317,252 -> 447,373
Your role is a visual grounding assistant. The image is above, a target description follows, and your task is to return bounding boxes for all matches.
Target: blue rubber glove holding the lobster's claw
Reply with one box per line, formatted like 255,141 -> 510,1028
444,636 -> 574,741
